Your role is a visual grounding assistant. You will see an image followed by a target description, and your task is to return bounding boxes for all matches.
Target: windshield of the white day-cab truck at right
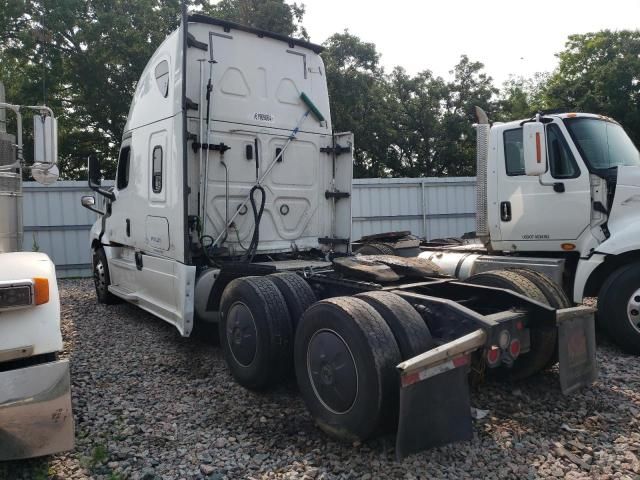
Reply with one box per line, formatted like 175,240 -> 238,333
564,117 -> 640,170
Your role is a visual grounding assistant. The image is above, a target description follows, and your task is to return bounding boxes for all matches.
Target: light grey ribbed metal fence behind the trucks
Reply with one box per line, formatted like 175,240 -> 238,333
23,177 -> 475,277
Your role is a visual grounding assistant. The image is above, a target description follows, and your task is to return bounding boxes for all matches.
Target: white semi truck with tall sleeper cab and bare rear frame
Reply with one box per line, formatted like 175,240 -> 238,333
82,10 -> 596,456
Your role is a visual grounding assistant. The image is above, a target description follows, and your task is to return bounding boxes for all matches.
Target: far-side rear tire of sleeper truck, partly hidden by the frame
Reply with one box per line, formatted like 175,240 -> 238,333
465,270 -> 558,381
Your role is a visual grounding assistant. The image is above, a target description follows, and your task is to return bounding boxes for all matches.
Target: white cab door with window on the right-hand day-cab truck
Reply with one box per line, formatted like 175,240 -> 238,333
496,121 -> 591,251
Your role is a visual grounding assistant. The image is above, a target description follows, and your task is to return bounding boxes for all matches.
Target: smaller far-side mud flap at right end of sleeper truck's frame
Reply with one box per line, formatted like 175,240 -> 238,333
556,307 -> 598,395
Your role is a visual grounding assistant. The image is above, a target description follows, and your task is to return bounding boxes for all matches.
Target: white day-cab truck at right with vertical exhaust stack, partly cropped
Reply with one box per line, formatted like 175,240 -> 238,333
360,109 -> 640,354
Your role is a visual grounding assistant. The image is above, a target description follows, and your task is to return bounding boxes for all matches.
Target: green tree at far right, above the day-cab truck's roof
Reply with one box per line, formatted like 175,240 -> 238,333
543,30 -> 640,145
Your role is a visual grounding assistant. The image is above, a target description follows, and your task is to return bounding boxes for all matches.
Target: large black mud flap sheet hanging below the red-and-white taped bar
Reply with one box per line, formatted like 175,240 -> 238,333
396,354 -> 473,460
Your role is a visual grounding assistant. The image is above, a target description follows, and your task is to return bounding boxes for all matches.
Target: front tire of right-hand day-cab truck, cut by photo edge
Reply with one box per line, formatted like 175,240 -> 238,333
597,262 -> 640,355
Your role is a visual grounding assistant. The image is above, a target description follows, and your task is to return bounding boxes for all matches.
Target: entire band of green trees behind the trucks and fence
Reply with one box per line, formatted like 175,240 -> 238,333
5,0 -> 640,179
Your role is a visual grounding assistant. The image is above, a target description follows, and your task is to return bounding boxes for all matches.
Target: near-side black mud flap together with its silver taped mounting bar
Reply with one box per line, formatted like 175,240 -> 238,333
396,329 -> 487,460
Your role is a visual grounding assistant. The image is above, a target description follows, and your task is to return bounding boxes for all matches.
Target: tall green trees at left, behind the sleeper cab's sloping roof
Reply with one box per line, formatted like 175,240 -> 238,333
0,0 -> 304,179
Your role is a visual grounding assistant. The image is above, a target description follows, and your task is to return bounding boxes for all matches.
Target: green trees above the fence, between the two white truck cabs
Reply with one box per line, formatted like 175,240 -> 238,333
323,31 -> 497,177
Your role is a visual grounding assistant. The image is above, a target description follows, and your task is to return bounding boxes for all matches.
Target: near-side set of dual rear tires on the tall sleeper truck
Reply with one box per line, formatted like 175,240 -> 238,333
219,273 -> 434,441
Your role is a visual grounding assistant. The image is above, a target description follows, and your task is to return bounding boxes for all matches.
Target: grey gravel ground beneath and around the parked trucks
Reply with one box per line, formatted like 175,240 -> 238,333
0,280 -> 640,480
